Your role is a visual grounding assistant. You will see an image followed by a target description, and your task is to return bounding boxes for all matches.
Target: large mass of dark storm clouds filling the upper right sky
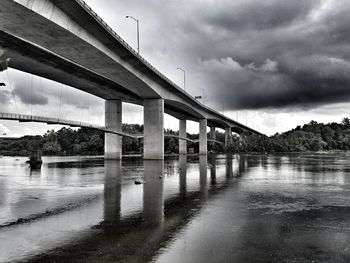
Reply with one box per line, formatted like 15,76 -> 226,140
180,1 -> 350,109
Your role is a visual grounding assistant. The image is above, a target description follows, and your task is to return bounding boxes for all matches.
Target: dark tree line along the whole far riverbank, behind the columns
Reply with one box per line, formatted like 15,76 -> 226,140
0,118 -> 350,156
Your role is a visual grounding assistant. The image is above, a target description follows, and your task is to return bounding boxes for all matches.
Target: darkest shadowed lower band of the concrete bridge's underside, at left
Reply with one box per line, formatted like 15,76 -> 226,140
0,30 -> 204,124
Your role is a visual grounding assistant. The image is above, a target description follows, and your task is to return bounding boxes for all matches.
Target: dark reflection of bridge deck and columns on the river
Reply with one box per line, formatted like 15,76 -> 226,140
28,156 -> 247,262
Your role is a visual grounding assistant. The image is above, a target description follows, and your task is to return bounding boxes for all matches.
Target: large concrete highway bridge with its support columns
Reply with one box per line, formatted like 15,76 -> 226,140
0,0 -> 262,159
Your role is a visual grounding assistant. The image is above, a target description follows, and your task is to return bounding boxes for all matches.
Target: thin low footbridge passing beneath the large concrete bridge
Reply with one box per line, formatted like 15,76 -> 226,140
0,112 -> 224,144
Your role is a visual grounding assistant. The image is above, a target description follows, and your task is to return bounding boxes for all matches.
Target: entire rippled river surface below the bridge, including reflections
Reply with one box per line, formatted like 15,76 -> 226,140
0,153 -> 350,263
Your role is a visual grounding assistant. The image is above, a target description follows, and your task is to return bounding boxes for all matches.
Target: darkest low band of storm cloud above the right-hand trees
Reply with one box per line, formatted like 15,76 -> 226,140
203,56 -> 350,109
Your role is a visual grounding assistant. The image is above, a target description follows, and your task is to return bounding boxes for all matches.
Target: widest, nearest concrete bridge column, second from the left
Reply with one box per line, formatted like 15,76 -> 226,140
143,99 -> 164,160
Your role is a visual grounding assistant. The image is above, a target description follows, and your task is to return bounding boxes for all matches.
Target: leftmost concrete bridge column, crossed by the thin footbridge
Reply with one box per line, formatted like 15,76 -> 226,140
105,100 -> 122,160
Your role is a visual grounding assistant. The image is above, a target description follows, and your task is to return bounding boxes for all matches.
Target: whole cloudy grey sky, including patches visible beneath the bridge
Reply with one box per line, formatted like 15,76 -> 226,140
0,0 -> 350,136
